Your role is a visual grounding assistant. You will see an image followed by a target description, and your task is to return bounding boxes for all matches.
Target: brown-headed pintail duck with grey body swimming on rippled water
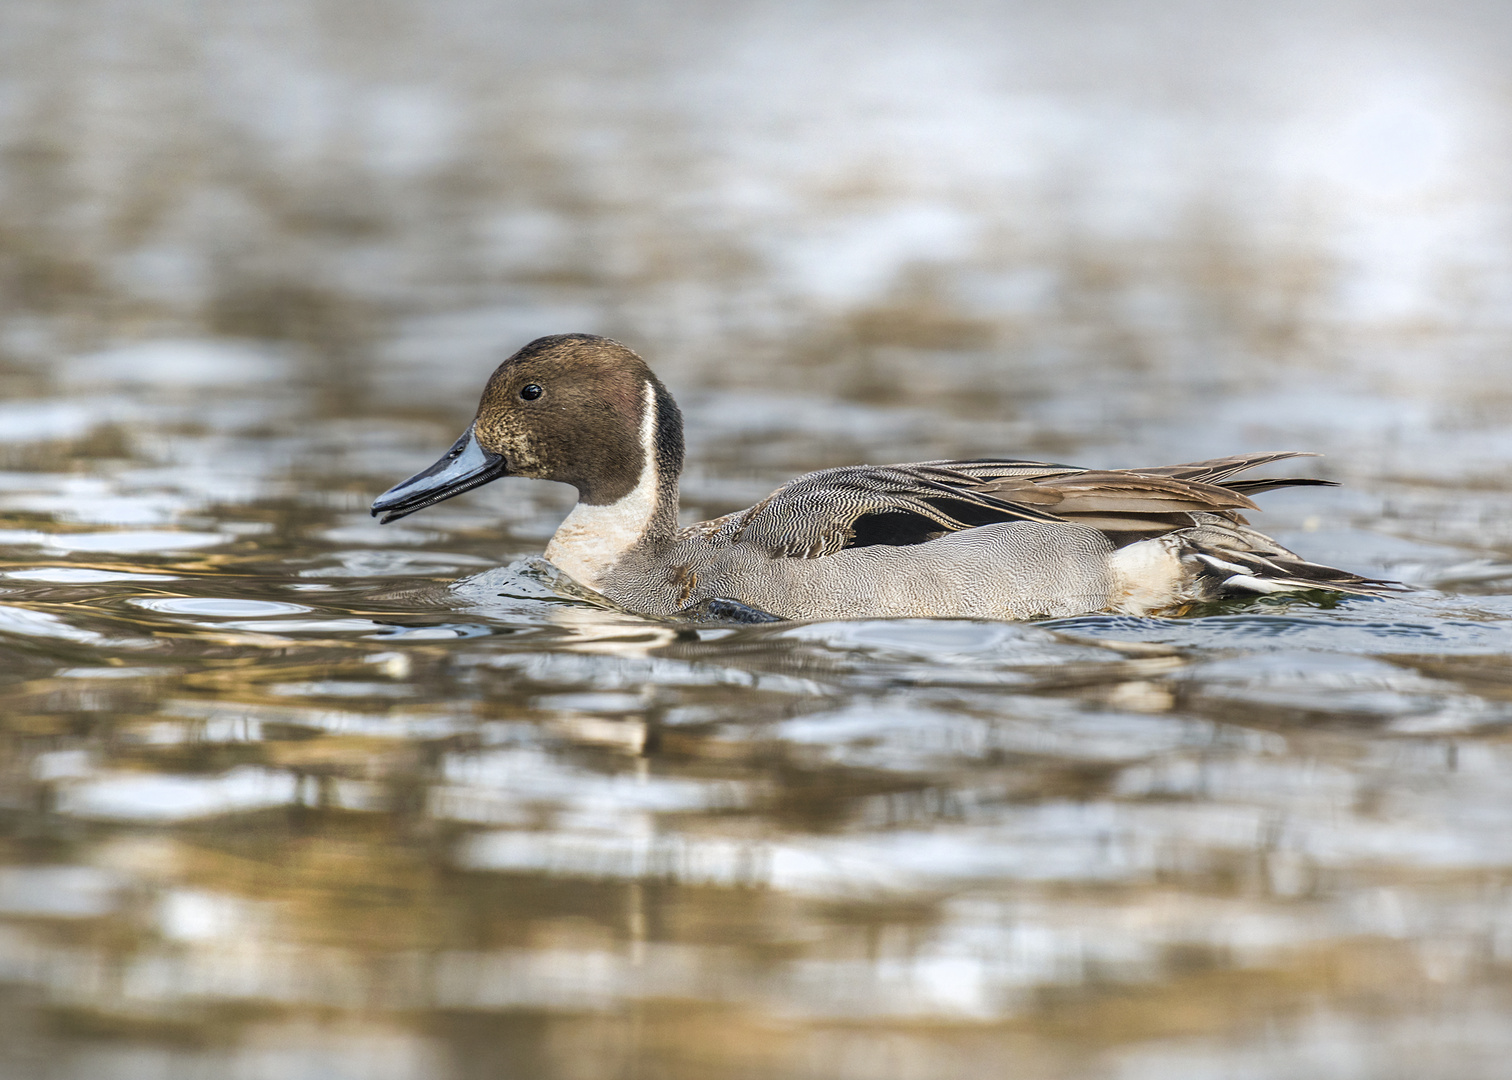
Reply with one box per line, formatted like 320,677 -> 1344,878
372,334 -> 1405,622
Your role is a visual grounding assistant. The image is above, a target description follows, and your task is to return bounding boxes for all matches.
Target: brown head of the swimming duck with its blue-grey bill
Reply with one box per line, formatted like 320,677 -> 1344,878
372,334 -> 682,523
